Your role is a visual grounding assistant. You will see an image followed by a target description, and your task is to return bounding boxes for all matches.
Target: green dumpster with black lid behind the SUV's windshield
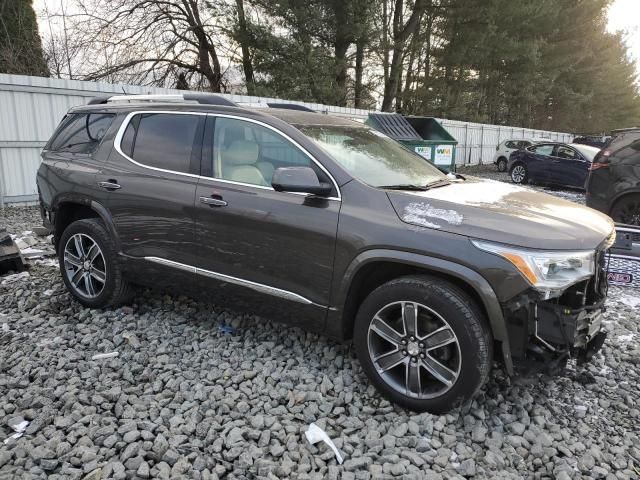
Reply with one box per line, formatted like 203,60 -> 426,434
366,113 -> 458,171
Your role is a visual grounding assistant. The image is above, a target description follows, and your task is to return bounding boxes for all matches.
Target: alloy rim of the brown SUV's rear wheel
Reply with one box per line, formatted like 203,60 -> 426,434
63,233 -> 107,298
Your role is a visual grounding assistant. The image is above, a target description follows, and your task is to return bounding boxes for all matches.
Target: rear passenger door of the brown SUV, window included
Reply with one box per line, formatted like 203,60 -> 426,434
98,111 -> 206,270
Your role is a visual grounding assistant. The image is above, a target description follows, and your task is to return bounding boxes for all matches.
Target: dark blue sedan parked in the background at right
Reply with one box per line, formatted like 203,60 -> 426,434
509,142 -> 600,189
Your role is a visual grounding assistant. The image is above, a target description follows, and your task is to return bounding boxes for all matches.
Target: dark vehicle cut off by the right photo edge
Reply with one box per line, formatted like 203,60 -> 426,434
587,128 -> 640,225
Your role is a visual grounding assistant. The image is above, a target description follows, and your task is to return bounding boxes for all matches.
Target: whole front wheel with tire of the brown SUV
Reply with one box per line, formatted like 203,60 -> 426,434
354,275 -> 493,413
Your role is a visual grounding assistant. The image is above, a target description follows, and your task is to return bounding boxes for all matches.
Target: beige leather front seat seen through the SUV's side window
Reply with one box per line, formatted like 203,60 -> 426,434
220,140 -> 273,186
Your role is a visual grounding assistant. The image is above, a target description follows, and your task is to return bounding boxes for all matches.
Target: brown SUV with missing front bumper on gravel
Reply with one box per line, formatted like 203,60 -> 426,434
37,94 -> 615,412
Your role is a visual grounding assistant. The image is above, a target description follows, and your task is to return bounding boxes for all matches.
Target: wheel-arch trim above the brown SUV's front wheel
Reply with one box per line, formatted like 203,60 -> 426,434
329,249 -> 513,375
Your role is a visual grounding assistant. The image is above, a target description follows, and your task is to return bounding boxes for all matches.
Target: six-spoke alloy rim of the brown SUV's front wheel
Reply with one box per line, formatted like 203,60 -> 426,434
367,302 -> 462,399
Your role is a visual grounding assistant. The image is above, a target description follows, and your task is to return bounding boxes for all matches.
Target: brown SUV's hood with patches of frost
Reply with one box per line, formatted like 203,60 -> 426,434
387,177 -> 614,250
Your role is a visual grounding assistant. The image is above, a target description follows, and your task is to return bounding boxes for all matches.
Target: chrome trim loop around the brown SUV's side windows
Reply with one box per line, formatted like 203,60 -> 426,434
113,110 -> 342,201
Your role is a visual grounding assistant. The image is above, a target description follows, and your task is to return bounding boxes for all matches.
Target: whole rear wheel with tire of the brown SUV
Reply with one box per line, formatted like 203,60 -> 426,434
58,218 -> 134,308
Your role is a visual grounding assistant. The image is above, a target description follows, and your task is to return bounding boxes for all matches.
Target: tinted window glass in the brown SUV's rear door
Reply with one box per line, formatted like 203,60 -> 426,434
120,113 -> 204,173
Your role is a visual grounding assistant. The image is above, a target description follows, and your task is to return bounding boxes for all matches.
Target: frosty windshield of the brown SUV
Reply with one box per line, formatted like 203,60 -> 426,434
296,125 -> 446,187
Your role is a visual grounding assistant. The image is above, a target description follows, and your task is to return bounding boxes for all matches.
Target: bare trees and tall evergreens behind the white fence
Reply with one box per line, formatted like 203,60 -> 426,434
0,0 -> 640,133
